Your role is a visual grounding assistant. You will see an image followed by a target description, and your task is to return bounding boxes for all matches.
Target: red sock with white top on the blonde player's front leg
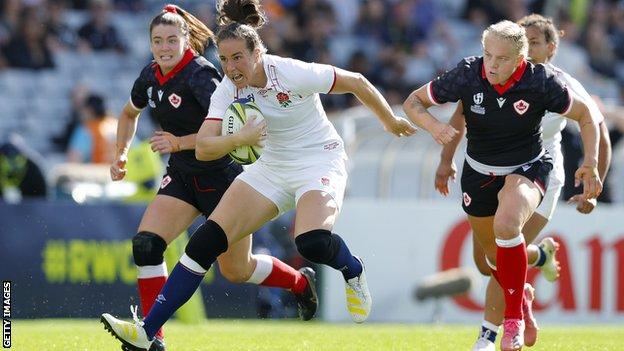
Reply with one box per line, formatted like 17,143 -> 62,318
495,234 -> 527,319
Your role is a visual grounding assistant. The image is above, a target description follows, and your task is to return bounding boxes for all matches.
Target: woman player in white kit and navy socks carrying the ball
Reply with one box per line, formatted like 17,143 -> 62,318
103,0 -> 416,350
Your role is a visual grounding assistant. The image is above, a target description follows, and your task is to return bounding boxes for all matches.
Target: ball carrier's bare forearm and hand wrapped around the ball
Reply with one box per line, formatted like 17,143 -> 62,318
195,117 -> 266,161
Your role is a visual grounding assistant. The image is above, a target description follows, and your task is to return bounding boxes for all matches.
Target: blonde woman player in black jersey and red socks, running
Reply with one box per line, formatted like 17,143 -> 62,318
403,21 -> 602,351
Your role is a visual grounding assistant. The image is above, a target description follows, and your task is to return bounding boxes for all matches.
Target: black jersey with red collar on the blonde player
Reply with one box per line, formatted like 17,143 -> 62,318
427,57 -> 572,166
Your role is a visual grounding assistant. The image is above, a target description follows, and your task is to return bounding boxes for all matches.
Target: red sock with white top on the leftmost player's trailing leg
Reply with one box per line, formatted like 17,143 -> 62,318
248,255 -> 308,294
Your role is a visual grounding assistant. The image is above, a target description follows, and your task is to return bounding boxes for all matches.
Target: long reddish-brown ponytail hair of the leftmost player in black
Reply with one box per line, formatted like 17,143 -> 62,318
150,4 -> 214,55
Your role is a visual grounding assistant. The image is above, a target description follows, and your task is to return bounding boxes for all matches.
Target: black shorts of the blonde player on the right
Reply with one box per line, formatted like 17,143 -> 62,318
461,154 -> 553,217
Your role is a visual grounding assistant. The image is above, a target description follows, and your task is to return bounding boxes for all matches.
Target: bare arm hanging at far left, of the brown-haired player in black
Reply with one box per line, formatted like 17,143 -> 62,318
110,101 -> 141,181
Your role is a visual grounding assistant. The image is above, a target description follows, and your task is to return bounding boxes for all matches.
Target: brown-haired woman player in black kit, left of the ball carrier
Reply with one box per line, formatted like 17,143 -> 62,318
100,5 -> 317,351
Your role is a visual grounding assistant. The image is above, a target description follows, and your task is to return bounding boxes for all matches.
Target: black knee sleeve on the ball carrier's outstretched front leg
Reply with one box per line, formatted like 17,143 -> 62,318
184,219 -> 228,270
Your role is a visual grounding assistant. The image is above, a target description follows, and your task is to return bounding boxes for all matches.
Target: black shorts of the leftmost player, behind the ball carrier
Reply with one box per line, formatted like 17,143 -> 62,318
158,163 -> 243,217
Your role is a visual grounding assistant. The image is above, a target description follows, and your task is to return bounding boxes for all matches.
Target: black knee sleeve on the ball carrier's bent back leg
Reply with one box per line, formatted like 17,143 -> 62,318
295,229 -> 341,263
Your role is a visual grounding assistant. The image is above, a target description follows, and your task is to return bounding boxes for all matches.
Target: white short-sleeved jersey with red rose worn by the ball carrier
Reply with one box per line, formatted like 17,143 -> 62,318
208,54 -> 346,162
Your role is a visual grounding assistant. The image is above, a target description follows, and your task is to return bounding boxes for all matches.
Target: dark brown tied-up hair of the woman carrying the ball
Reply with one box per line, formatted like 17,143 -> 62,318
216,0 -> 266,53
